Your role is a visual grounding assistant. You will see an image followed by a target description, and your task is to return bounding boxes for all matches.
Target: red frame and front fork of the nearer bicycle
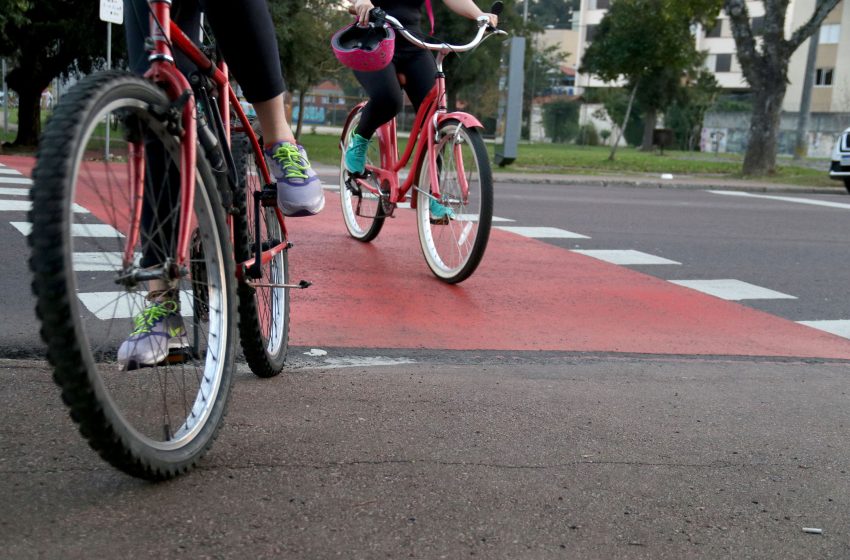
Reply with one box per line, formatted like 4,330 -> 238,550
124,0 -> 287,279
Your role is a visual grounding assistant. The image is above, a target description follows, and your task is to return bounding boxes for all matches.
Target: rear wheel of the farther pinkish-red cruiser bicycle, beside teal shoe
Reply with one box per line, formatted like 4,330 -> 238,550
339,109 -> 386,243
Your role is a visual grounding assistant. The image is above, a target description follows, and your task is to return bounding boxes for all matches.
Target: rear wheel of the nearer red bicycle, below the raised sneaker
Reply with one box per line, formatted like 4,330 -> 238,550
233,136 -> 289,377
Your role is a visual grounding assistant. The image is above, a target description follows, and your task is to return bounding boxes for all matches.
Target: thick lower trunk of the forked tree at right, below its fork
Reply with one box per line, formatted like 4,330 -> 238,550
743,78 -> 786,175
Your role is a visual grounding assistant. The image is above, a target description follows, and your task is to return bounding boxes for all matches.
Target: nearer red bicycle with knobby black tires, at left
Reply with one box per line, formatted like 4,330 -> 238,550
29,1 -> 298,479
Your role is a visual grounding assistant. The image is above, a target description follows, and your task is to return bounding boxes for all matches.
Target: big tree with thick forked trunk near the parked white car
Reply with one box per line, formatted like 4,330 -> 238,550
723,0 -> 841,175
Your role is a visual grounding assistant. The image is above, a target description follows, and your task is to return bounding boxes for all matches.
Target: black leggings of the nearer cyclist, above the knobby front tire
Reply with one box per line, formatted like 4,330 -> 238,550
124,0 -> 284,103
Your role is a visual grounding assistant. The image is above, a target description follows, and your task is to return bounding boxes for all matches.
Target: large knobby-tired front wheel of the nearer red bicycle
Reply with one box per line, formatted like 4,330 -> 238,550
28,72 -> 235,480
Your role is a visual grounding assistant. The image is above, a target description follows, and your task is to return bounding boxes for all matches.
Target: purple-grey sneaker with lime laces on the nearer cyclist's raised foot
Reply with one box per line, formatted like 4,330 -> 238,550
266,142 -> 325,217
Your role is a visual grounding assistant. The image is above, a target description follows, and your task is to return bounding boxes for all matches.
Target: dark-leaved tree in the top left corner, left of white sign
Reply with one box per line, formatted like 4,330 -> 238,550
0,0 -> 115,146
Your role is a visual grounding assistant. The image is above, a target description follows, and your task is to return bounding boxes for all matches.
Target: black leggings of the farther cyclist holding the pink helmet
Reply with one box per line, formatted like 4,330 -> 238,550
354,40 -> 437,138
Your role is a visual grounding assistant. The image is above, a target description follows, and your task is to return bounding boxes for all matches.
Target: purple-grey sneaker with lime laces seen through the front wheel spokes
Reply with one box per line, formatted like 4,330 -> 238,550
118,299 -> 189,370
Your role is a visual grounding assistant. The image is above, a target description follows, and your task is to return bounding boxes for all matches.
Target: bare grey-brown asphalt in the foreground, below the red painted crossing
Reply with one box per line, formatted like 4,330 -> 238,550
0,349 -> 850,560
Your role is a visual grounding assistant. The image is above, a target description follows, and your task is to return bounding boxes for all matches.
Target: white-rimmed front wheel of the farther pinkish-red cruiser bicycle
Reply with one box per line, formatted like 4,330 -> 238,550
416,119 -> 493,284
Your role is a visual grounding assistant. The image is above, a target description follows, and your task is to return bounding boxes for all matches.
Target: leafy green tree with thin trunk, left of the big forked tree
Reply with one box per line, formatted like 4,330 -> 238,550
581,0 -> 722,155
